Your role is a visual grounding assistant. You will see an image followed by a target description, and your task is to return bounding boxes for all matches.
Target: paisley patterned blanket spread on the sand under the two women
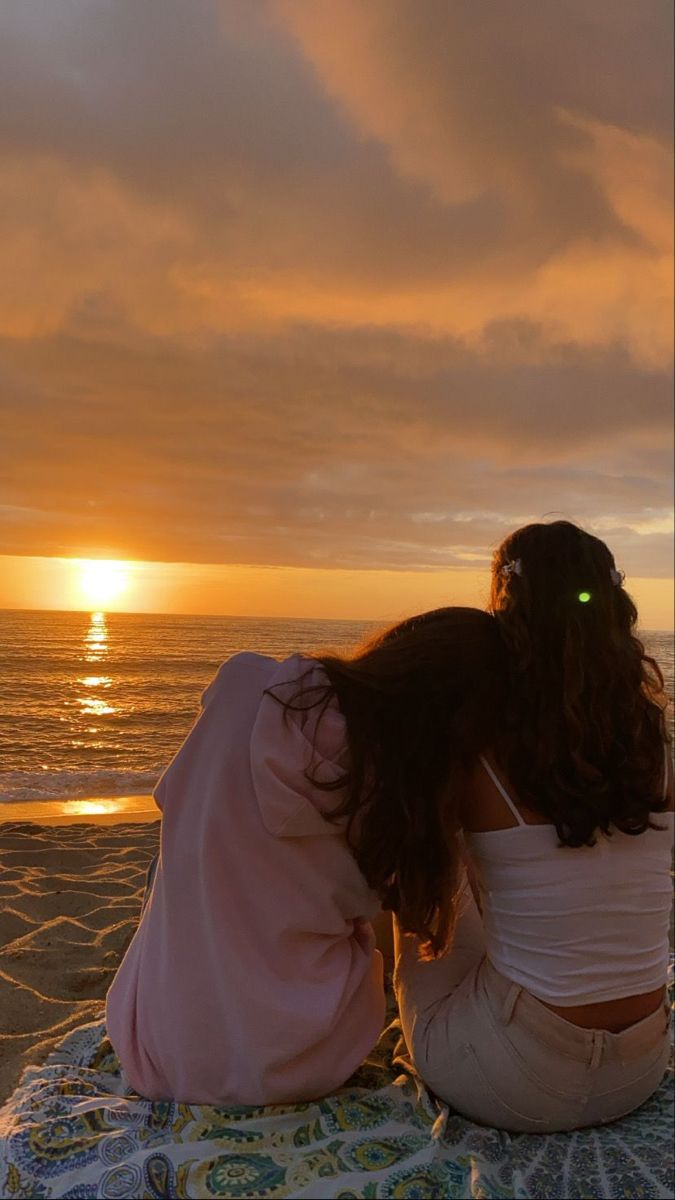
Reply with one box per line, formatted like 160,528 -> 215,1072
0,997 -> 675,1200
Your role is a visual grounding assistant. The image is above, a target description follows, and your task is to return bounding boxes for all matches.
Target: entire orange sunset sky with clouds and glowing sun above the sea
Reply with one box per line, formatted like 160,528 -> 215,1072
0,0 -> 674,629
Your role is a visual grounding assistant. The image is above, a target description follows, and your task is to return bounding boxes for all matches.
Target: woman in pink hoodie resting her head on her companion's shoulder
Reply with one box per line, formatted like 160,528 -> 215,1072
106,608 -> 503,1104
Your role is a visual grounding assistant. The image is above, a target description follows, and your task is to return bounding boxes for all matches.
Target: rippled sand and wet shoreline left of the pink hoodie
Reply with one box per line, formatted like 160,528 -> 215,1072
0,797 -> 160,1103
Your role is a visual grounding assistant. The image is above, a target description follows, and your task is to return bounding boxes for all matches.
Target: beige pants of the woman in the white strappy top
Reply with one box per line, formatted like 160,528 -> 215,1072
394,888 -> 670,1133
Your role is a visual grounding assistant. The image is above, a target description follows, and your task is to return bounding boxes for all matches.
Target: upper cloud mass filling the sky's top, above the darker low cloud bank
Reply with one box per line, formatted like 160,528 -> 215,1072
0,0 -> 671,355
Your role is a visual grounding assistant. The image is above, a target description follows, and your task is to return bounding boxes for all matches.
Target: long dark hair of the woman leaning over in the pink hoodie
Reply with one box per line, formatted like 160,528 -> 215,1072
269,607 -> 504,954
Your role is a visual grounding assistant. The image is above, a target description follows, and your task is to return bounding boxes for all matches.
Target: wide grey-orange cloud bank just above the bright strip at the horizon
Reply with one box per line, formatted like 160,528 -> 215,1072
0,319 -> 670,574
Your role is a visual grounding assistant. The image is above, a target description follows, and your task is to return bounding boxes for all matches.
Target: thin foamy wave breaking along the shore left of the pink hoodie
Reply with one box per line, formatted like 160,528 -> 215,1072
0,768 -> 161,804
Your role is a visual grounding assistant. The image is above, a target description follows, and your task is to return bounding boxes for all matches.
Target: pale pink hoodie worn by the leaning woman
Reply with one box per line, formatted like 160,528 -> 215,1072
106,654 -> 384,1104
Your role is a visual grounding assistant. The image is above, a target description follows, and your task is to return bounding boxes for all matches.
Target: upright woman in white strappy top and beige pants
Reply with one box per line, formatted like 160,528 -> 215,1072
395,521 -> 673,1133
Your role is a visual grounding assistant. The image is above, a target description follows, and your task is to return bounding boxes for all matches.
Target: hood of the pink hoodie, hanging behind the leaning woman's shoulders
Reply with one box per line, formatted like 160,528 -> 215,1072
251,654 -> 348,838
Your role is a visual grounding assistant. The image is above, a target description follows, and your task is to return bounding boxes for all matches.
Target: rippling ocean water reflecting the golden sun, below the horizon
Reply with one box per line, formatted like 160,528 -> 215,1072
0,611 -> 674,803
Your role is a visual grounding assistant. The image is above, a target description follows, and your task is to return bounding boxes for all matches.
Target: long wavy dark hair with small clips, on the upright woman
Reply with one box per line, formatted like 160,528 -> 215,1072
490,521 -> 669,846
